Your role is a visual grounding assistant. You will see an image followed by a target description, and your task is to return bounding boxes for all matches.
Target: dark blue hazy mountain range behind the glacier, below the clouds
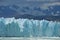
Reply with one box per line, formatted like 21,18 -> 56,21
0,5 -> 60,20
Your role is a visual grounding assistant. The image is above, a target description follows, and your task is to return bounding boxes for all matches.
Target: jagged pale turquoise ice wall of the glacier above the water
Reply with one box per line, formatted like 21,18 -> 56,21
0,17 -> 60,37
